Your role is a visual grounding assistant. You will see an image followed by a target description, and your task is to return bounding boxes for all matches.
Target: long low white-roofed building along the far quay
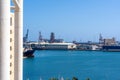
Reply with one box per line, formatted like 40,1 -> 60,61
32,43 -> 76,50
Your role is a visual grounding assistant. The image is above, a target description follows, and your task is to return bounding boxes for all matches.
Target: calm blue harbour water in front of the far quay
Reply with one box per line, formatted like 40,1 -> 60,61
23,50 -> 120,80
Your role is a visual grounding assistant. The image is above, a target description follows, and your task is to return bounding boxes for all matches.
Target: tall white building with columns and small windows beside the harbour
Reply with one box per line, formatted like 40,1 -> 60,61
0,0 -> 23,80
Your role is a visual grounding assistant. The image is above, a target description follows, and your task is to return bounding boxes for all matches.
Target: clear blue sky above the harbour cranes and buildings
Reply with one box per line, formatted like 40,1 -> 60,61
24,0 -> 120,42
